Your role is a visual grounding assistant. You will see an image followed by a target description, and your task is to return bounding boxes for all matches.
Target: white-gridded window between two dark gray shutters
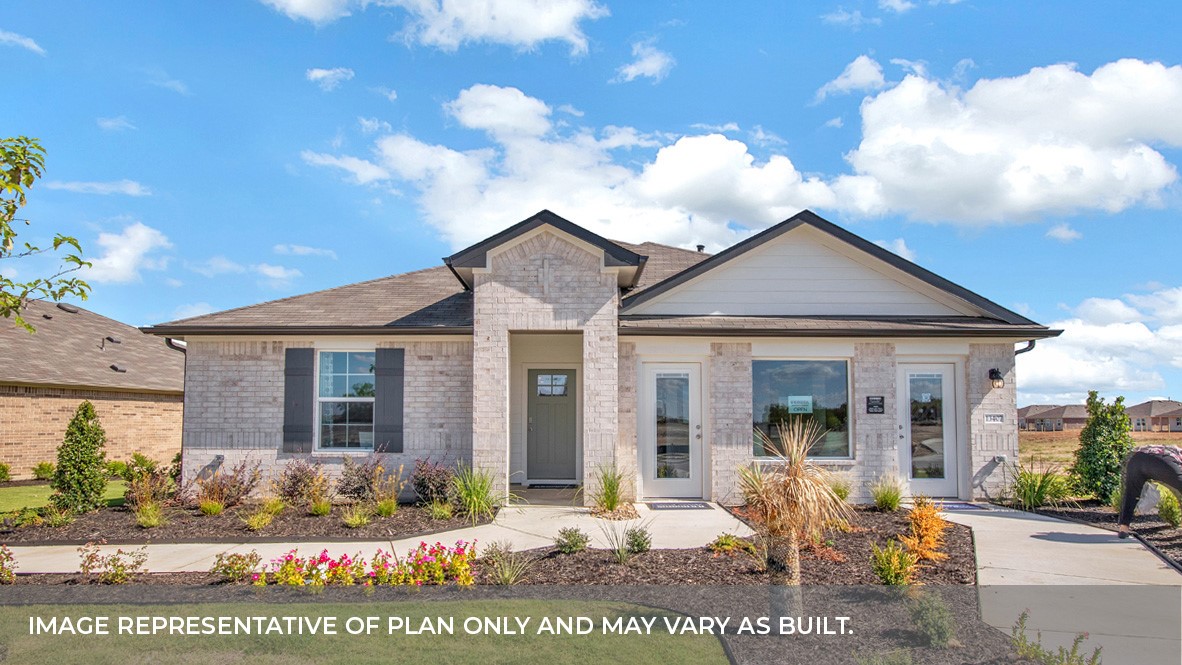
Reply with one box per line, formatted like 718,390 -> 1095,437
317,351 -> 374,450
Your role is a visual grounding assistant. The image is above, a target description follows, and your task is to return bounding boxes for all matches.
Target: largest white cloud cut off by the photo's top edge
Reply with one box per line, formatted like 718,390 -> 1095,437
381,0 -> 609,54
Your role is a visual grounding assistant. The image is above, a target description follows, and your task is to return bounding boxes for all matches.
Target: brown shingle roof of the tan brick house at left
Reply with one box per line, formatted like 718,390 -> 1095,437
0,300 -> 184,392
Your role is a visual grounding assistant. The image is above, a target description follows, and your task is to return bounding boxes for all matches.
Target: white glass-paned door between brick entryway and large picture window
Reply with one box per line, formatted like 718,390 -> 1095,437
639,363 -> 702,498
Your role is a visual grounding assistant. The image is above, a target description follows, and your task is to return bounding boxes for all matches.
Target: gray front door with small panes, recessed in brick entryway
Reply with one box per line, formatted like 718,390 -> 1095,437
525,370 -> 578,481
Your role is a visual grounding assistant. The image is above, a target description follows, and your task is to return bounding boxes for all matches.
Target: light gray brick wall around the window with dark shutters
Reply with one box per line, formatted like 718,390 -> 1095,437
183,340 -> 472,484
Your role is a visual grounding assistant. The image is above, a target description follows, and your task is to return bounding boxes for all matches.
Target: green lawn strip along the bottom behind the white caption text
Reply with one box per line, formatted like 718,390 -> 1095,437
0,600 -> 727,665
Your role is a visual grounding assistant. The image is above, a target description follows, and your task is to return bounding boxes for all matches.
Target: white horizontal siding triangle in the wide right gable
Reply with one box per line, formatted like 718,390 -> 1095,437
628,227 -> 980,317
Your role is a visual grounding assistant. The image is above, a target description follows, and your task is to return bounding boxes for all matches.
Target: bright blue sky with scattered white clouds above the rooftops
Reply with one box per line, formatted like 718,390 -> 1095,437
0,0 -> 1182,403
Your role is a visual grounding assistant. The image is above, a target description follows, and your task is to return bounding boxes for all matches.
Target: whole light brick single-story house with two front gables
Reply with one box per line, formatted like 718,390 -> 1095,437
144,211 -> 1059,503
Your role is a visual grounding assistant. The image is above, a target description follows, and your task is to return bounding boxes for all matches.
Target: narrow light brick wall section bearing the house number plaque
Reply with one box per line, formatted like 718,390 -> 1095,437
965,344 -> 1018,498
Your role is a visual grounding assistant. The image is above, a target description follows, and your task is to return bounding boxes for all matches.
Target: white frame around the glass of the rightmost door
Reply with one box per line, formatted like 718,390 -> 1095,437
896,360 -> 969,497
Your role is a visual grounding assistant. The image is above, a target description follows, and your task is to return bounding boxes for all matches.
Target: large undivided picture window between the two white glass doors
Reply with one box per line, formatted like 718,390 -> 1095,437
752,360 -> 851,457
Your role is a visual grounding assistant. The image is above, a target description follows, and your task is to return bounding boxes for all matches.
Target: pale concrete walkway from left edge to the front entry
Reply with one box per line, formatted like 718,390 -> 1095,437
9,503 -> 751,573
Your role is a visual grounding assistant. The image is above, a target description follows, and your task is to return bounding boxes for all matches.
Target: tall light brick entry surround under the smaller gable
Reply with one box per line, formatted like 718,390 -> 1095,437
472,232 -> 619,507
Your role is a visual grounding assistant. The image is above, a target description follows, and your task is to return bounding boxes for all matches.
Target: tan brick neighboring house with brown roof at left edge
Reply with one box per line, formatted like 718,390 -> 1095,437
0,300 -> 184,478
